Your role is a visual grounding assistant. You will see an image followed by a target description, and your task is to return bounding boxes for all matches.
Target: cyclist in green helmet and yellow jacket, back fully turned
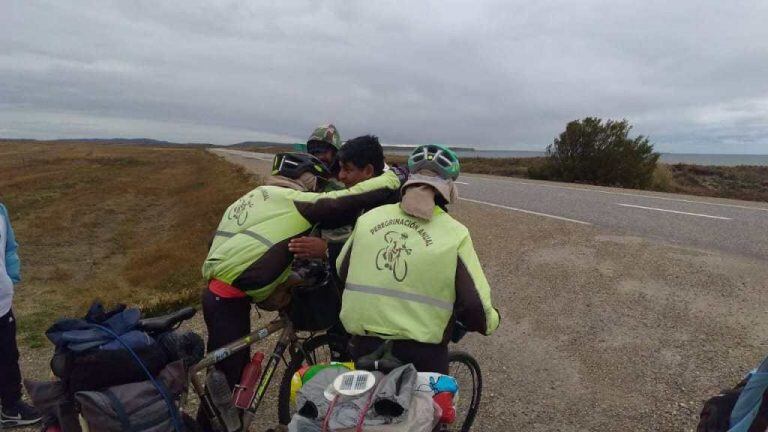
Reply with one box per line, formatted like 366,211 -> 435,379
336,145 -> 500,373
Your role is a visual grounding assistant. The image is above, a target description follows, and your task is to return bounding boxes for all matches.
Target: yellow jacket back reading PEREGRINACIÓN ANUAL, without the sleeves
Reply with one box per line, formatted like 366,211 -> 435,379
340,204 -> 467,343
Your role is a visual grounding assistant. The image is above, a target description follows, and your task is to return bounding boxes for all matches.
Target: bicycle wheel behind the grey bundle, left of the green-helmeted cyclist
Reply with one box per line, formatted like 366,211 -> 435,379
277,334 -> 346,425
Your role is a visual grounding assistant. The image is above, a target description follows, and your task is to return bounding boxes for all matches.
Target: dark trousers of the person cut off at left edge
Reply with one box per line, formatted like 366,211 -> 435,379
0,311 -> 21,407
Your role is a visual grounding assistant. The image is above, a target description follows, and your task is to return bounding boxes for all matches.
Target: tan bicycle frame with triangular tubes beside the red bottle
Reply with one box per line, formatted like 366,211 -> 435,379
188,315 -> 297,430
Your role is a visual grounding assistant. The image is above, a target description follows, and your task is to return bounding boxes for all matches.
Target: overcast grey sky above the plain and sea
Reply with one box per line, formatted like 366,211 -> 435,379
0,0 -> 768,154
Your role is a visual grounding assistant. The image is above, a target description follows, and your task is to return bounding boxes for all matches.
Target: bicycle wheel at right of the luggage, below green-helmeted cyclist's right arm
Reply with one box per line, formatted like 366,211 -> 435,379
447,351 -> 483,432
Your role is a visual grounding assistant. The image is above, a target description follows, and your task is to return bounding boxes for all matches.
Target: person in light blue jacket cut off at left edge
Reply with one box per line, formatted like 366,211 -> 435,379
0,204 -> 40,429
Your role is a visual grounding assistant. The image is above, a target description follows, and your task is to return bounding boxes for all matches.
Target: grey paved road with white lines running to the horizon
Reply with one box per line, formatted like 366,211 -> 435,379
214,150 -> 768,259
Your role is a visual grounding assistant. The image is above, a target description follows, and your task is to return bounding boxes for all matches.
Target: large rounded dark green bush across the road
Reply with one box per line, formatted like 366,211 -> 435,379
540,117 -> 659,188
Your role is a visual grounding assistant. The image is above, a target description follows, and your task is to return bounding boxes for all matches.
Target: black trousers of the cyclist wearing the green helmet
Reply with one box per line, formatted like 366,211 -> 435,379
349,336 -> 448,374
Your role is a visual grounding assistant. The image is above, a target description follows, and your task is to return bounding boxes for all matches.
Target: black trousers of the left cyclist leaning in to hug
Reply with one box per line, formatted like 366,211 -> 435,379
197,288 -> 251,430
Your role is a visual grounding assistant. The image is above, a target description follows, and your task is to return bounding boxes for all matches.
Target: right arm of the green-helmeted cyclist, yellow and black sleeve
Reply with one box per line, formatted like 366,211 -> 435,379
454,235 -> 501,335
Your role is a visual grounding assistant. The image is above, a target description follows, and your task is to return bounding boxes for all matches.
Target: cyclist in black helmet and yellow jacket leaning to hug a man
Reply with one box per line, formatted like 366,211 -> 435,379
202,153 -> 405,394
